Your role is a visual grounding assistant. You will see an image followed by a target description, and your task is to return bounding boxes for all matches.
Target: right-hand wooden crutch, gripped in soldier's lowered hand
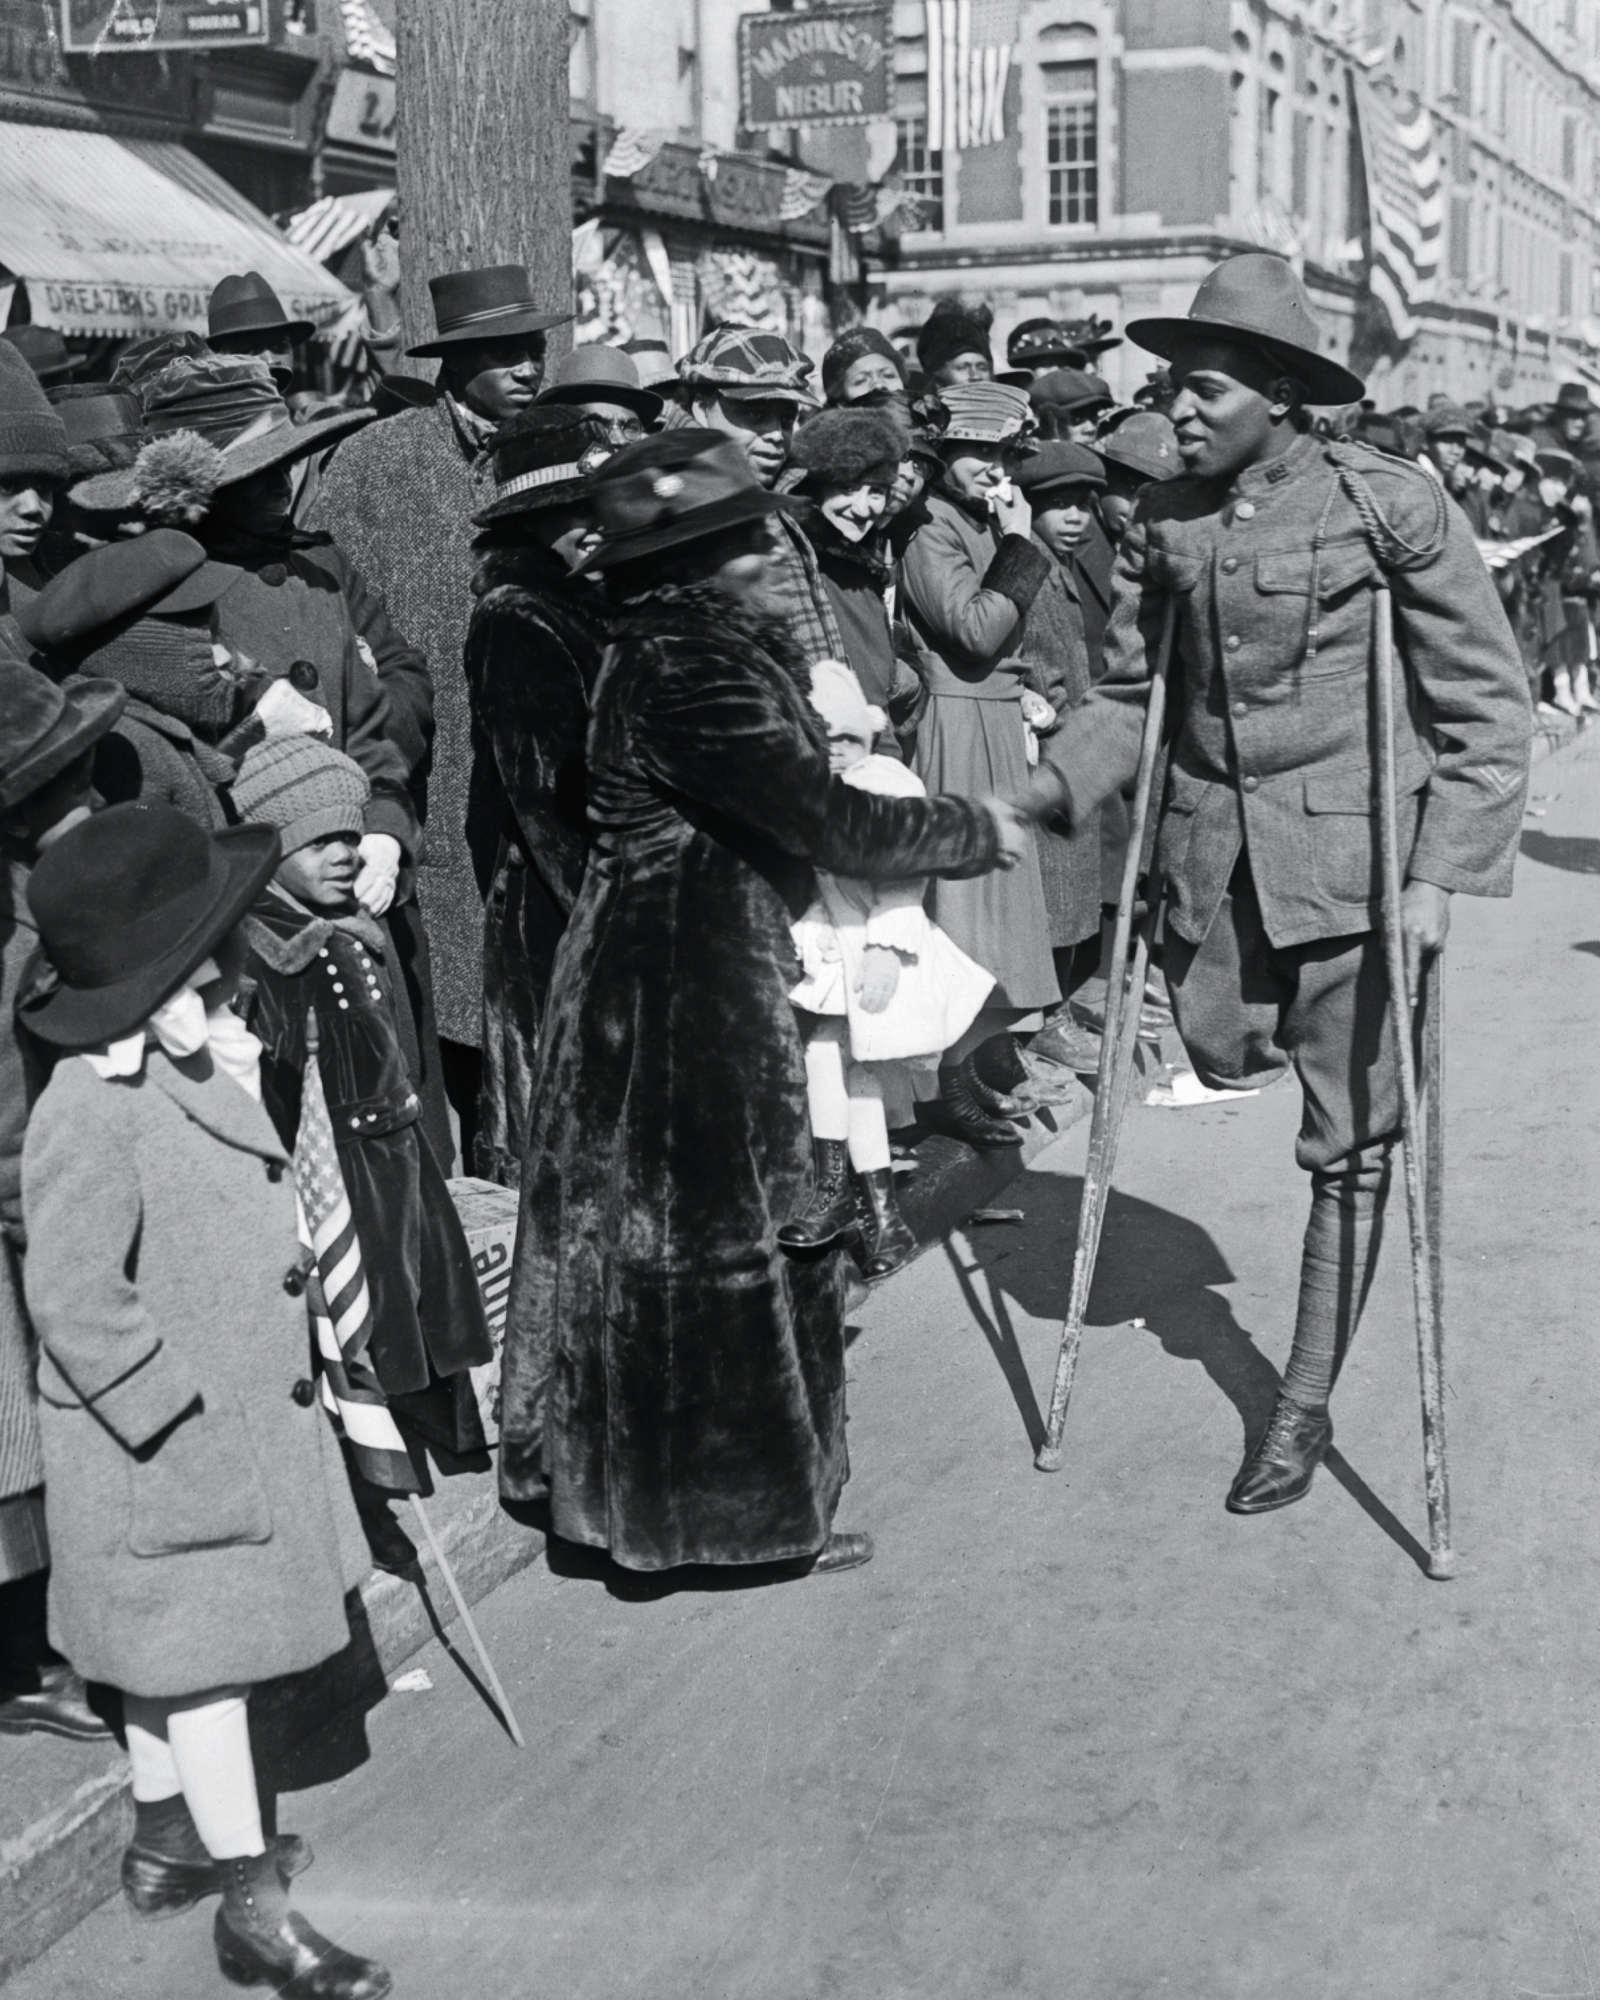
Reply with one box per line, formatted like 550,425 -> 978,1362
1374,586 -> 1456,1580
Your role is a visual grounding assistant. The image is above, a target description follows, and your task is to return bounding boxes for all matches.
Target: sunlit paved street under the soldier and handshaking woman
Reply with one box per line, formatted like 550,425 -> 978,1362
8,744 -> 1600,2000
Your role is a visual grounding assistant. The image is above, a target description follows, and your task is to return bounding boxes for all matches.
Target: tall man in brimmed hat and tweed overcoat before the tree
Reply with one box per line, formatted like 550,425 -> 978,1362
308,264 -> 572,1162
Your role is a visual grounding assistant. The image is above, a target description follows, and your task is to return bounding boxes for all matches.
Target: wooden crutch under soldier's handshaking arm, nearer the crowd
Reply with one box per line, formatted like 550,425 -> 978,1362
1034,598 -> 1178,1472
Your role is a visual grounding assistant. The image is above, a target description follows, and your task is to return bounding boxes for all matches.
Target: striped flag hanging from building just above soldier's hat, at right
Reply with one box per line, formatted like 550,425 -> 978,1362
1350,70 -> 1444,342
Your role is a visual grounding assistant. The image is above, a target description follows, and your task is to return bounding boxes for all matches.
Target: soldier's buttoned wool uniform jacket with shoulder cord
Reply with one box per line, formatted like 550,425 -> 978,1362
1034,434 -> 1532,948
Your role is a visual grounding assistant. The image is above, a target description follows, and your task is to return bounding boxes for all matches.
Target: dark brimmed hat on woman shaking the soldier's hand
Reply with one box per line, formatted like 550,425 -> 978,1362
574,426 -> 788,574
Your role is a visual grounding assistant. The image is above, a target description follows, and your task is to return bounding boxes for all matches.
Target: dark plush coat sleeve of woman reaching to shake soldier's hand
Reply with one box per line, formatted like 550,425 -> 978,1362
638,648 -> 1000,882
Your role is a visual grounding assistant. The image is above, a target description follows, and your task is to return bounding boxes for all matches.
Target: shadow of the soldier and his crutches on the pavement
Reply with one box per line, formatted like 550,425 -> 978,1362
964,1168 -> 1440,1574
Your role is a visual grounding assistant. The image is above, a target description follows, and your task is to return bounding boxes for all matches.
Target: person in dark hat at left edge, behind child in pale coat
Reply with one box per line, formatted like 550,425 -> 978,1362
0,658 -> 126,1740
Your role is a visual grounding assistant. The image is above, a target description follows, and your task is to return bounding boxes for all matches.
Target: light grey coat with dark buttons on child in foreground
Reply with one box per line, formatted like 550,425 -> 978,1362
22,1048 -> 370,1696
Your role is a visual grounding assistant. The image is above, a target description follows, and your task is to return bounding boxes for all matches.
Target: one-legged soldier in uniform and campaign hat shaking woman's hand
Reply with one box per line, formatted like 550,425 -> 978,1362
1020,252 -> 1530,1514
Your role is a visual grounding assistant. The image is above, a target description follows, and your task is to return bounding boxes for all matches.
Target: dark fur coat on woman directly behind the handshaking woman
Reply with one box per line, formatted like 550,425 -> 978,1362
466,540 -> 606,1188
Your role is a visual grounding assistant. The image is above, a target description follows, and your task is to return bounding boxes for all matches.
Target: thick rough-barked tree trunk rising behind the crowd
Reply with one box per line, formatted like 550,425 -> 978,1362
396,0 -> 572,374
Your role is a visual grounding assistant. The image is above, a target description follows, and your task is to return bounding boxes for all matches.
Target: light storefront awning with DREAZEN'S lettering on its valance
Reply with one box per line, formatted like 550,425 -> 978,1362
0,124 -> 352,338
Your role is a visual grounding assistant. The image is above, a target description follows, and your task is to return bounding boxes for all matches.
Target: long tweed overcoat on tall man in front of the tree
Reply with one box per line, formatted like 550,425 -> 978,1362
310,396 -> 494,1048
